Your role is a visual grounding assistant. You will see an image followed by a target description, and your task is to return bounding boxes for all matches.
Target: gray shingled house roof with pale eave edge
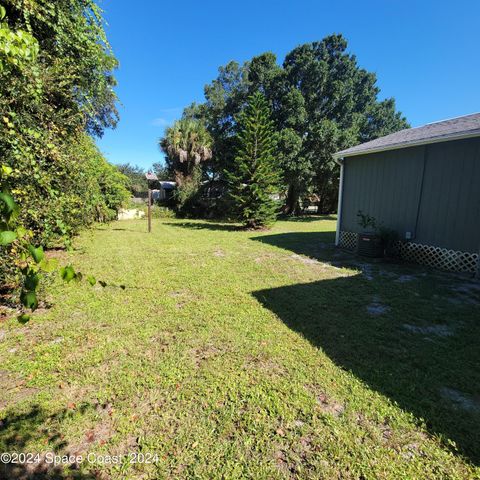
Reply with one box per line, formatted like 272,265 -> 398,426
334,113 -> 480,159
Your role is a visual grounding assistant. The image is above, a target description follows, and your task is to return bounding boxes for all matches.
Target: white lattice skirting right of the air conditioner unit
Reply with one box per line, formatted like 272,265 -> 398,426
398,242 -> 478,273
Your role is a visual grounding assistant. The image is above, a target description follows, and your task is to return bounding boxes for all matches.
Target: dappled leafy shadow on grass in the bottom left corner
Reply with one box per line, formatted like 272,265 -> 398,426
0,404 -> 96,480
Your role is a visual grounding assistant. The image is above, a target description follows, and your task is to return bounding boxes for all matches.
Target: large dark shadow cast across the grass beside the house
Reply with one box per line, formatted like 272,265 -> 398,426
253,274 -> 480,465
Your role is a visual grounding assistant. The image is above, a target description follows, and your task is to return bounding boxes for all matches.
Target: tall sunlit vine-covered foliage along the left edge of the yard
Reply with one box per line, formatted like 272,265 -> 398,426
0,0 -> 129,305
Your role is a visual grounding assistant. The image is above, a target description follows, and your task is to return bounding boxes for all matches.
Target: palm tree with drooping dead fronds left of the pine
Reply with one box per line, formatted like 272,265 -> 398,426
160,118 -> 212,187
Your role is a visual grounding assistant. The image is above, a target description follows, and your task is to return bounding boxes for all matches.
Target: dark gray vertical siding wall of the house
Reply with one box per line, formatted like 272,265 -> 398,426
341,138 -> 480,252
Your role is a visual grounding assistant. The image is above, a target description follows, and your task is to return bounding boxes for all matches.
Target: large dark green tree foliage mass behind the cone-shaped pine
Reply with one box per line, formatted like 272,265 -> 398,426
184,35 -> 408,213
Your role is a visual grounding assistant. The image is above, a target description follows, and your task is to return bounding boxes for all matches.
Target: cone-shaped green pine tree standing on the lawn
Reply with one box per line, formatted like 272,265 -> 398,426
226,92 -> 279,228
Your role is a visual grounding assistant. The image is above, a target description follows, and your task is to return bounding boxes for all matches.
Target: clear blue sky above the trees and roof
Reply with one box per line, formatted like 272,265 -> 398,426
98,0 -> 480,168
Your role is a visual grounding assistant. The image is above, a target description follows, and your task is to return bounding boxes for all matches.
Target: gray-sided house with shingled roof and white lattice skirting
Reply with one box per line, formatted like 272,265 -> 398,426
334,113 -> 480,276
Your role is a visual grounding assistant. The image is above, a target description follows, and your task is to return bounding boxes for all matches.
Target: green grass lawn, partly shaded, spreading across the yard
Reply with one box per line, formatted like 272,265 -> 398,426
0,218 -> 480,479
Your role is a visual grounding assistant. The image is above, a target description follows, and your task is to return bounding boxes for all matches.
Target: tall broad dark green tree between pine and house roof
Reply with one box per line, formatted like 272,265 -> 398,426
283,35 -> 408,212
